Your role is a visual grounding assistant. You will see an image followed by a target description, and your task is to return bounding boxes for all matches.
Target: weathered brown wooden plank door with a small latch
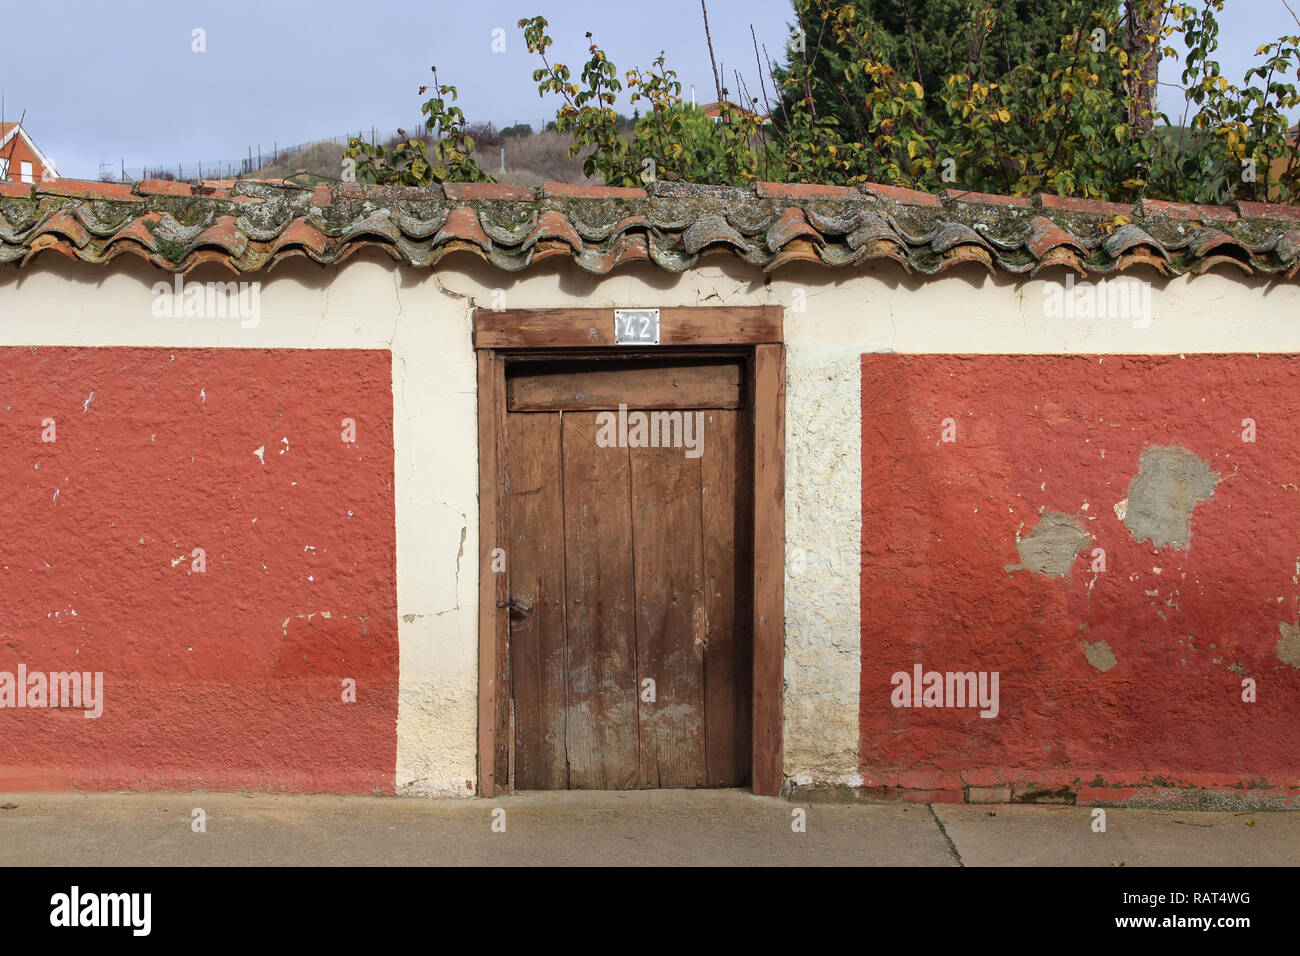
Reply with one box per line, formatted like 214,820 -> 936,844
504,359 -> 753,790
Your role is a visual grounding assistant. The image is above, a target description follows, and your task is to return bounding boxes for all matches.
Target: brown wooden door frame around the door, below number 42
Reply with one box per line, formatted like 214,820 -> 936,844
473,306 -> 785,797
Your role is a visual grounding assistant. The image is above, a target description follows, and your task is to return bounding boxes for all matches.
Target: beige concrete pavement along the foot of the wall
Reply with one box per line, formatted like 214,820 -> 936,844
0,791 -> 1300,866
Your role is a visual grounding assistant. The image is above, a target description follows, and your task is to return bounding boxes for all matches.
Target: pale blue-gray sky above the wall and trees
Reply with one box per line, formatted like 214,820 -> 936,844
0,0 -> 1300,178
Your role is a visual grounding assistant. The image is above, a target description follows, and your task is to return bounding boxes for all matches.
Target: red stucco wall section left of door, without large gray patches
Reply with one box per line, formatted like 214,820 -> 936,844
0,349 -> 398,792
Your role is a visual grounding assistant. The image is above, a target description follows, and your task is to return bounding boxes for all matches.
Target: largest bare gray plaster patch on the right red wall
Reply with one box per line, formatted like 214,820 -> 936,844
1123,445 -> 1219,548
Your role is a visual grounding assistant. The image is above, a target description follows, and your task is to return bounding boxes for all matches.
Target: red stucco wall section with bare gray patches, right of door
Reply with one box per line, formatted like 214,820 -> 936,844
861,355 -> 1300,790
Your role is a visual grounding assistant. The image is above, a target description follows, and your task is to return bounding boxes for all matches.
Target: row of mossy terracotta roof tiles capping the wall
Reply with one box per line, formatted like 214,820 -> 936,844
0,179 -> 1300,280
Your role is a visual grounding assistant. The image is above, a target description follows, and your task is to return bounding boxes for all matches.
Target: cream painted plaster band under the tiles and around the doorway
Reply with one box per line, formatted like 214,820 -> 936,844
0,256 -> 1300,795
